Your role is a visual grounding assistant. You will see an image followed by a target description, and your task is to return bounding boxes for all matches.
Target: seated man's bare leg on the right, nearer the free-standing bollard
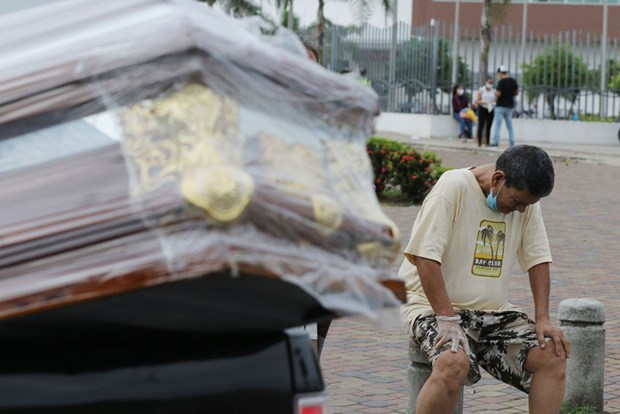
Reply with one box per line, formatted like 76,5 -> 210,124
524,342 -> 566,414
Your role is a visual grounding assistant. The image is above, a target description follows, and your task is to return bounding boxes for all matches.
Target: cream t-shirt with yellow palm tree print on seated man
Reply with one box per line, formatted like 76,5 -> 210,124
399,169 -> 552,325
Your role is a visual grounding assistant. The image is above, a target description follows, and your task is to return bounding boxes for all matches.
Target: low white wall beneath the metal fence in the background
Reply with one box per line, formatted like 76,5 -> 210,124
375,112 -> 620,145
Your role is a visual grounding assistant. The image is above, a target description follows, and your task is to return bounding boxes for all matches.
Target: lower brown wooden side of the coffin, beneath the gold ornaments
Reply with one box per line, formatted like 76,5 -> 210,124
0,144 -> 402,318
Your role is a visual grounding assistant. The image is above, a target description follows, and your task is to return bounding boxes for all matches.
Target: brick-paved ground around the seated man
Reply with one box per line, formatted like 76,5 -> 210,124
321,144 -> 620,414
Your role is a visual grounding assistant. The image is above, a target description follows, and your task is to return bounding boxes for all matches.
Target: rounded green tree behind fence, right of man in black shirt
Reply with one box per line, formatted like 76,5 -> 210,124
523,44 -> 591,119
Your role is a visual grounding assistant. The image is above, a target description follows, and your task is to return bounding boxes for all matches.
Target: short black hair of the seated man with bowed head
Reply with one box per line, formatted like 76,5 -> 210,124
495,145 -> 555,198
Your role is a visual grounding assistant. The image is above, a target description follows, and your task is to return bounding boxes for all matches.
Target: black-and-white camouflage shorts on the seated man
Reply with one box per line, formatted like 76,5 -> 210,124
413,311 -> 538,392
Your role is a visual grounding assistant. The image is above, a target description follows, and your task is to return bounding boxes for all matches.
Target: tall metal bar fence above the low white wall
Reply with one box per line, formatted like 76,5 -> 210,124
323,21 -> 620,122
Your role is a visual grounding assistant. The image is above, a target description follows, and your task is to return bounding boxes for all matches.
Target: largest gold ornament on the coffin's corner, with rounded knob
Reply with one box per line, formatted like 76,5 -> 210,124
120,84 -> 255,222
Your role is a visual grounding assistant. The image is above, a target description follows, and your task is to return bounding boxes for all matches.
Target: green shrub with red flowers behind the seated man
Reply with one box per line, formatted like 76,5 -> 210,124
367,137 -> 447,204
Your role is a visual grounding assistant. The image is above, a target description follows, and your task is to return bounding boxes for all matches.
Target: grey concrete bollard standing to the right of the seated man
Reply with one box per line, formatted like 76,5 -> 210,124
558,299 -> 605,413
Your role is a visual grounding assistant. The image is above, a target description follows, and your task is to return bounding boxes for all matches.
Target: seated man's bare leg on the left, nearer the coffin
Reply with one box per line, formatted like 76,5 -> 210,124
416,349 -> 470,414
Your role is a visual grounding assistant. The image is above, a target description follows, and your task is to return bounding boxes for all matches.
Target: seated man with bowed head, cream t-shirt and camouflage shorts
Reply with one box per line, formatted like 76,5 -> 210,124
399,145 -> 570,414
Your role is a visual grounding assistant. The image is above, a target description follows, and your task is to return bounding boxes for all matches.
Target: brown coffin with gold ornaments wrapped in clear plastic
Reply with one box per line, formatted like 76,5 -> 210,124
0,0 -> 399,326
